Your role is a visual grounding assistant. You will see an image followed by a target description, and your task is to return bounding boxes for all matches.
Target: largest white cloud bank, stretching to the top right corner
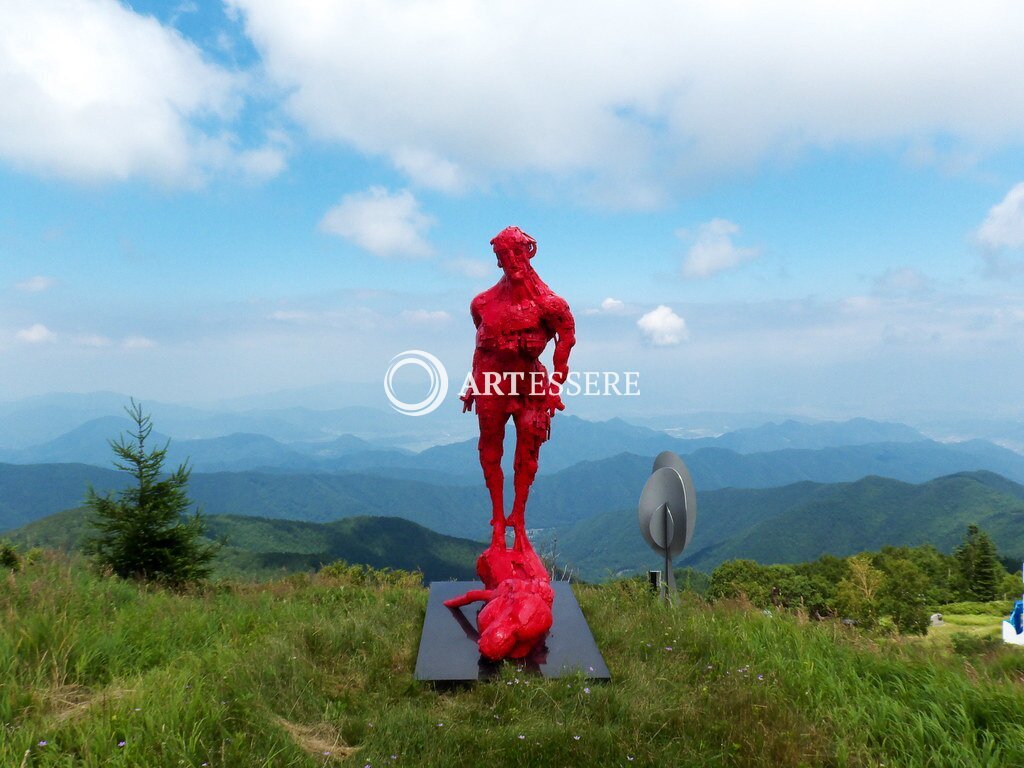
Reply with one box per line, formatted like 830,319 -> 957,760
228,0 -> 1024,203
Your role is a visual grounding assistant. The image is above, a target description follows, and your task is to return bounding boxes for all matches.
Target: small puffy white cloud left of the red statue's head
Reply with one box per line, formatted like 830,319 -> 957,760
319,186 -> 434,257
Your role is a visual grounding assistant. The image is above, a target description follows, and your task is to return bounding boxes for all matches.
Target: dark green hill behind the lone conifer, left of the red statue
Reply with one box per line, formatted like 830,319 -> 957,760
6,509 -> 485,582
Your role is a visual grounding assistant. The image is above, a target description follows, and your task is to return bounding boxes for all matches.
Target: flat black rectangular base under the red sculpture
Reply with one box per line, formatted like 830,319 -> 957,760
416,582 -> 611,682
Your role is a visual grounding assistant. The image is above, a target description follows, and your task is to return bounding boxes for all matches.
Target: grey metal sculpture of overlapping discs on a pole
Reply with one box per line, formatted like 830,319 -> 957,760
637,451 -> 697,592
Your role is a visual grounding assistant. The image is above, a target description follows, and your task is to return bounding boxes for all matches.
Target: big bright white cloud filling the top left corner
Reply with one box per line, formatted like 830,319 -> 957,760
0,0 -> 280,184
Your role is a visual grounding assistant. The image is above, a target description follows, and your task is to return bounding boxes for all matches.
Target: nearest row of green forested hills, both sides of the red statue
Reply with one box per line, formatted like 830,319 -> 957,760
5,472 -> 1024,581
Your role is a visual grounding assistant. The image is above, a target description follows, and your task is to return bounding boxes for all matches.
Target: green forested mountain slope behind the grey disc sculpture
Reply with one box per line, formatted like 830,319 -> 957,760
544,472 -> 1024,580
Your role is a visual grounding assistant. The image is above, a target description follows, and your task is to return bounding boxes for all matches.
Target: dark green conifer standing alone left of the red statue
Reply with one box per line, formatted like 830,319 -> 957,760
85,399 -> 217,587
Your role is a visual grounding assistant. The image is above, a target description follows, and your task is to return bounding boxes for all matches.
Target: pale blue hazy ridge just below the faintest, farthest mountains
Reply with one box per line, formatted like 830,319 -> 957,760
0,412 -> 987,482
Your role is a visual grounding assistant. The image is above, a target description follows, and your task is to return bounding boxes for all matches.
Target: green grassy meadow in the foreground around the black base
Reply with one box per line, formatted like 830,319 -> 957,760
6,556 -> 1024,768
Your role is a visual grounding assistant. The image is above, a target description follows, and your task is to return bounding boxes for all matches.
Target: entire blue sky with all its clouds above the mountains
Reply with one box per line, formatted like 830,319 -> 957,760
0,0 -> 1024,421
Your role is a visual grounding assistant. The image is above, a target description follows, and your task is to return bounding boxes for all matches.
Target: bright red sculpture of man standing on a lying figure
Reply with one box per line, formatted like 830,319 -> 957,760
444,226 -> 575,659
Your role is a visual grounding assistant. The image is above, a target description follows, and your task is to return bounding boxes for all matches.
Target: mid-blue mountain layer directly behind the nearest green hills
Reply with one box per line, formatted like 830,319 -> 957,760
9,434 -> 1024,538
